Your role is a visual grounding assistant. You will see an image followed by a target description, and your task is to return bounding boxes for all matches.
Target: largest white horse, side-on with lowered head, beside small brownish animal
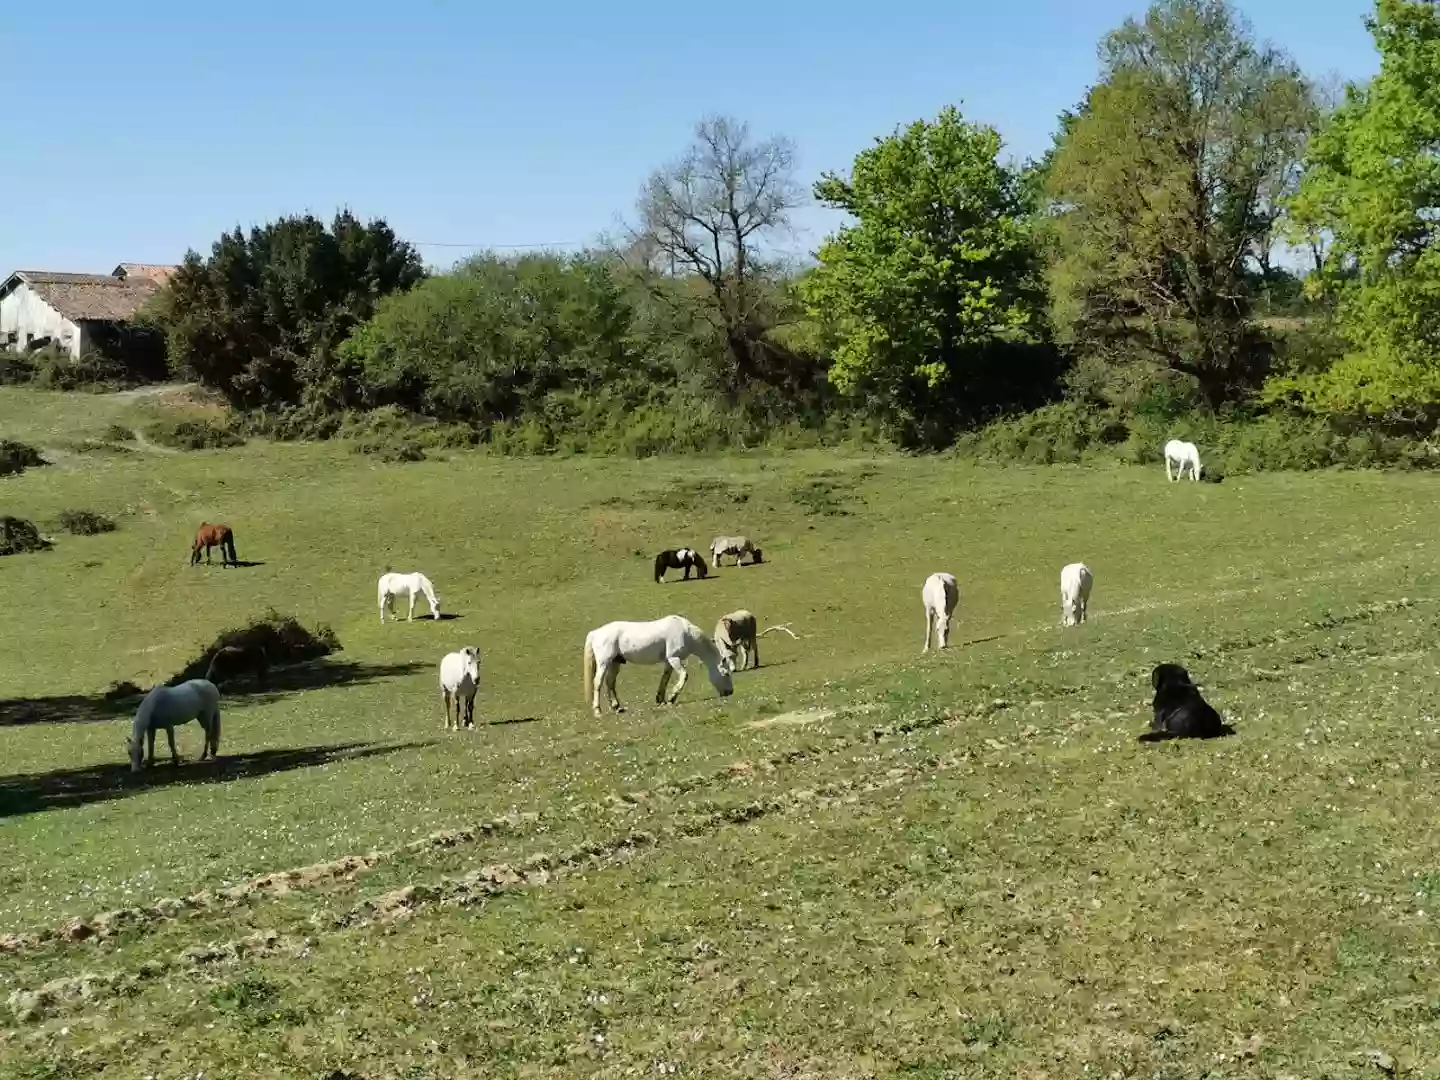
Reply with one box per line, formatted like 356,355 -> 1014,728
585,615 -> 734,717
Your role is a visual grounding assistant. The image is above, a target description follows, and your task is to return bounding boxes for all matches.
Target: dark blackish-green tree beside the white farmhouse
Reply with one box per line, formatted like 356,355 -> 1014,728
160,212 -> 425,408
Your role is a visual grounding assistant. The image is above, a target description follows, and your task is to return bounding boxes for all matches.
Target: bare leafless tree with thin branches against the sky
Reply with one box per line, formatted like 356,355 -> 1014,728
629,117 -> 808,399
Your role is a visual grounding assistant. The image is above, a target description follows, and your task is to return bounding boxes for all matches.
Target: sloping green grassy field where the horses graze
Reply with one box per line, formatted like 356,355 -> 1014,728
0,389 -> 1440,1080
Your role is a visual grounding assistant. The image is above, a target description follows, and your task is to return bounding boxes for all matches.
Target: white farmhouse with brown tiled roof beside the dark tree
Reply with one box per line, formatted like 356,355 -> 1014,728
0,262 -> 179,359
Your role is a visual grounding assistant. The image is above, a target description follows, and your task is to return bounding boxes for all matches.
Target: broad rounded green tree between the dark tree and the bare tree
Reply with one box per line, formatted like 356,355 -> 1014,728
340,255 -> 642,423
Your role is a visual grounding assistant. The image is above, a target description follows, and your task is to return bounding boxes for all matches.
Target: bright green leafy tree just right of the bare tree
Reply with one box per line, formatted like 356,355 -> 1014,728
801,107 -> 1054,445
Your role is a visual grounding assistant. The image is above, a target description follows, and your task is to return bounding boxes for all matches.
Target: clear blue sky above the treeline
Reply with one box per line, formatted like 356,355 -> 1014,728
0,0 -> 1377,274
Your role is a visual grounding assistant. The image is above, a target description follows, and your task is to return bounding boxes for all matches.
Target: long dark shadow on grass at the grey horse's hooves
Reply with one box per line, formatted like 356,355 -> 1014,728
0,736 -> 433,819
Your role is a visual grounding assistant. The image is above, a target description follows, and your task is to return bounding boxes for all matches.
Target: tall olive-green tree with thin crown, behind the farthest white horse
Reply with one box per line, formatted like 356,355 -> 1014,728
1045,0 -> 1316,406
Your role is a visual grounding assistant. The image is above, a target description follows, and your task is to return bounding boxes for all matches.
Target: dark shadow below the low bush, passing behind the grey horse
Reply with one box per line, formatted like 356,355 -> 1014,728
0,660 -> 433,727
